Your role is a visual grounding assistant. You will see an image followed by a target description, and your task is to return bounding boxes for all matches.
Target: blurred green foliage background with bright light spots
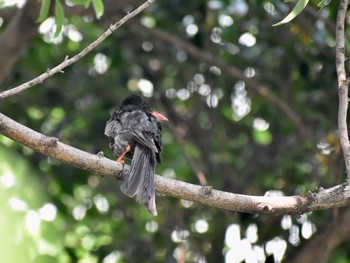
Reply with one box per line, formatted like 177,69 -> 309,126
0,0 -> 350,263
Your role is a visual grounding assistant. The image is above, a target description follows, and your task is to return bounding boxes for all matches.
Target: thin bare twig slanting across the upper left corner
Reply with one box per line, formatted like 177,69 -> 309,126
0,0 -> 156,100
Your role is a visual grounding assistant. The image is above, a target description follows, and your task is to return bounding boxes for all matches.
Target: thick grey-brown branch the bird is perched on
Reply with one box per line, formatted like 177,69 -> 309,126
0,113 -> 350,216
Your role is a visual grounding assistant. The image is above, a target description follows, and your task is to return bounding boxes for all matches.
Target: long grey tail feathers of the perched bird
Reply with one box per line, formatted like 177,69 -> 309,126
120,144 -> 157,215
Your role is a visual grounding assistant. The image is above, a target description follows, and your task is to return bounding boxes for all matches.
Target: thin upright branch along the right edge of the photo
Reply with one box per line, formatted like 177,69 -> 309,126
336,0 -> 350,183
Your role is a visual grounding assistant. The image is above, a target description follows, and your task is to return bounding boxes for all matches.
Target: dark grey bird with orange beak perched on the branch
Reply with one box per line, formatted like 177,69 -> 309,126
105,93 -> 168,215
